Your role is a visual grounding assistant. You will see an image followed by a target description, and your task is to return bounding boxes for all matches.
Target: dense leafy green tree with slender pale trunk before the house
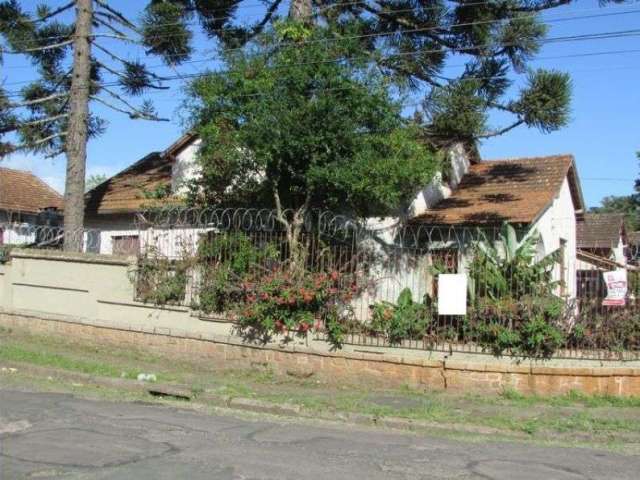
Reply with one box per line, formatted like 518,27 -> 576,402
189,22 -> 438,270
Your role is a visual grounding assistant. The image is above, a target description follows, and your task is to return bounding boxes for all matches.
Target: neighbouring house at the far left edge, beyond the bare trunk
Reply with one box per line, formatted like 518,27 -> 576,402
0,167 -> 63,244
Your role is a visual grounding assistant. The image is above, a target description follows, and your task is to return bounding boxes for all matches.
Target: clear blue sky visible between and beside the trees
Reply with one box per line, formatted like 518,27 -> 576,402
0,0 -> 640,206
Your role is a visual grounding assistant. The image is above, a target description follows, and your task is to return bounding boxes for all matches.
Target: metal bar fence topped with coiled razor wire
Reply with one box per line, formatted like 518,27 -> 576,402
0,209 -> 640,358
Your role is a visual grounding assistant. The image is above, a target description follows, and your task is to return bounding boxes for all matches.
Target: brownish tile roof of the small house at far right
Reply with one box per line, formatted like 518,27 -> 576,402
576,213 -> 624,248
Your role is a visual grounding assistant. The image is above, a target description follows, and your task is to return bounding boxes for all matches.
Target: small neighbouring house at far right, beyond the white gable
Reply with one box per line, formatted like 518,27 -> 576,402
576,213 -> 630,297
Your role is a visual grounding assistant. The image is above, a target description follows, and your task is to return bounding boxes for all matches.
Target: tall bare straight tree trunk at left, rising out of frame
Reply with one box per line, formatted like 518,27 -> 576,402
64,0 -> 93,252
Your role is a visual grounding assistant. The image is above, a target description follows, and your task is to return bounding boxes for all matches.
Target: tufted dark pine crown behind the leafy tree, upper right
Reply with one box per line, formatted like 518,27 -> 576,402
168,0 -> 576,139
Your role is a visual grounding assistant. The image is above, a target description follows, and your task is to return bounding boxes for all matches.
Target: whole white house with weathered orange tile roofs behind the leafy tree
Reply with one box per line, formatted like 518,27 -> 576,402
85,135 -> 584,300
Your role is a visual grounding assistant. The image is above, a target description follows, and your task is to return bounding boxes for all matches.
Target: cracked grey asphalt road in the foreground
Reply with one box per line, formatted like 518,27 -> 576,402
0,390 -> 640,480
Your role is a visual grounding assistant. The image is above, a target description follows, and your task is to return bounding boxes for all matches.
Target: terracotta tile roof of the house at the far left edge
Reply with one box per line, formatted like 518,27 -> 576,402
0,168 -> 63,213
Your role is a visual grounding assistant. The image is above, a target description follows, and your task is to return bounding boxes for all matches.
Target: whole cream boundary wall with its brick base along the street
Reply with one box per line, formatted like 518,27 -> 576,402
0,251 -> 640,396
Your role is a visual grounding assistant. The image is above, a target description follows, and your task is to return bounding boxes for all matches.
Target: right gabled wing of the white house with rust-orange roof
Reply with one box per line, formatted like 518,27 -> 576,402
374,155 -> 584,299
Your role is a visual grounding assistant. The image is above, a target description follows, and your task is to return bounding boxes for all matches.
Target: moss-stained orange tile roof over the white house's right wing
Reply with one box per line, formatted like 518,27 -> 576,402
413,155 -> 583,225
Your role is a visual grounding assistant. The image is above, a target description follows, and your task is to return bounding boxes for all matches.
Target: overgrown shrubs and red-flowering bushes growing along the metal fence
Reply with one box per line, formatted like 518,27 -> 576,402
136,219 -> 640,358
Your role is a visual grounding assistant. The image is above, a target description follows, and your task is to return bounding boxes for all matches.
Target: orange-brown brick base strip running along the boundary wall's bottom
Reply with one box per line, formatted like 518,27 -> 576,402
0,312 -> 640,396
